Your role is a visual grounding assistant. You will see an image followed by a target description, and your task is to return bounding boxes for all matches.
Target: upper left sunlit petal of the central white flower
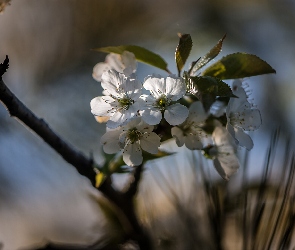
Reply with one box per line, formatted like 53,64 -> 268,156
143,75 -> 166,99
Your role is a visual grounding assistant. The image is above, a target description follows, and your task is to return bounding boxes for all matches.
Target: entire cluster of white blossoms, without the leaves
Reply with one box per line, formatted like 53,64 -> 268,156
90,51 -> 261,179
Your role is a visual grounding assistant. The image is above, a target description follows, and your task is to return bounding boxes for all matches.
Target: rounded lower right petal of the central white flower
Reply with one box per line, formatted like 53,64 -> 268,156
164,103 -> 188,125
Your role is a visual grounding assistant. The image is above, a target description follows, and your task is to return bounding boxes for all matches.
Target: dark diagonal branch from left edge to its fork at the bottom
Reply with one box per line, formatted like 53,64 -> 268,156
0,57 -> 151,249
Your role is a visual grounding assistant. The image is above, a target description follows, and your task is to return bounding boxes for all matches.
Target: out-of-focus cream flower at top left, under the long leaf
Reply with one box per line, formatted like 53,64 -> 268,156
92,51 -> 136,82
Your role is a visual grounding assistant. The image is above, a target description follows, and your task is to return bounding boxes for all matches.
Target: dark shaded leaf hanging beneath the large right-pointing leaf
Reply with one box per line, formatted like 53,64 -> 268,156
189,76 -> 235,111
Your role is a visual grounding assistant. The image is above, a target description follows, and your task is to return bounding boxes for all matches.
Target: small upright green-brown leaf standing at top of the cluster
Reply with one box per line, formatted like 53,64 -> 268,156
175,33 -> 193,76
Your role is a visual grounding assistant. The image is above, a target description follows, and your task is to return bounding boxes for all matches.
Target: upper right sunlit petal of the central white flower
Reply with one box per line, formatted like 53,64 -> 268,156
165,76 -> 186,101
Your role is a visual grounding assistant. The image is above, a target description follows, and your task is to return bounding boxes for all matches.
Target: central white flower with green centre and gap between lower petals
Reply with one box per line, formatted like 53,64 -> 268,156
141,75 -> 188,125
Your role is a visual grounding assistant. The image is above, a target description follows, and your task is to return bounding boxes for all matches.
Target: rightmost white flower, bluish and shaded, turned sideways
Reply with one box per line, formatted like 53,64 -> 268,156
226,80 -> 261,150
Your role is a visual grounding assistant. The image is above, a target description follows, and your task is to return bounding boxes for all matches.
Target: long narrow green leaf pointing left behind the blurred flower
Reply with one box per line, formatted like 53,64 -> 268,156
94,45 -> 170,73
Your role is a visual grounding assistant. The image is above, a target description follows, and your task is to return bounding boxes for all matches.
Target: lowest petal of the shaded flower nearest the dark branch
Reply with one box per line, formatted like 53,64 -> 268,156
123,142 -> 142,167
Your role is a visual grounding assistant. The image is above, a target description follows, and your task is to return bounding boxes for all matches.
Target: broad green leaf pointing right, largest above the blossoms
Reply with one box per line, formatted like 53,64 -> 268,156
202,52 -> 276,79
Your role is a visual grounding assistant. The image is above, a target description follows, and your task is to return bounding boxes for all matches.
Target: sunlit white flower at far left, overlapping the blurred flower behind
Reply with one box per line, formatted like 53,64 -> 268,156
90,70 -> 142,128
